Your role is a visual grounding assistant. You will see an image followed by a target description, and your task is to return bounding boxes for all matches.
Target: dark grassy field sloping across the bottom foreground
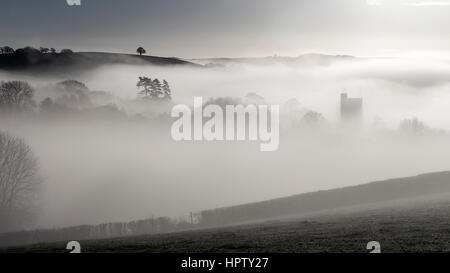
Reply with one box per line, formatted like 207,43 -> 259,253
2,193 -> 450,253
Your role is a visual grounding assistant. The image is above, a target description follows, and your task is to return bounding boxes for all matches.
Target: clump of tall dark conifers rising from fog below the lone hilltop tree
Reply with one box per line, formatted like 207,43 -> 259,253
136,77 -> 172,100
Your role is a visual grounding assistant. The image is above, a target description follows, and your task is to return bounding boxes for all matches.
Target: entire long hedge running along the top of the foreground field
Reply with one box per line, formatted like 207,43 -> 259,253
0,172 -> 450,249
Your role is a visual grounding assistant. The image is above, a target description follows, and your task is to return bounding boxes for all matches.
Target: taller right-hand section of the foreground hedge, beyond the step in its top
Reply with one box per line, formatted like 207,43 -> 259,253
201,172 -> 450,226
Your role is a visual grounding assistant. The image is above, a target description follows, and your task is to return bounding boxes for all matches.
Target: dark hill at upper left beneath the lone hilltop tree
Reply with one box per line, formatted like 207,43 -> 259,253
0,50 -> 200,72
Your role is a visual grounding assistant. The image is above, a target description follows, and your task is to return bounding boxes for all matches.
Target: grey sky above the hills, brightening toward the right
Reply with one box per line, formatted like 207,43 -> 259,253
0,0 -> 450,58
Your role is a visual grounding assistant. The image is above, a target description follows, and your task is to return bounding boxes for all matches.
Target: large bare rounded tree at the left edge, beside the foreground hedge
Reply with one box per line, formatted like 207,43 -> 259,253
0,132 -> 41,232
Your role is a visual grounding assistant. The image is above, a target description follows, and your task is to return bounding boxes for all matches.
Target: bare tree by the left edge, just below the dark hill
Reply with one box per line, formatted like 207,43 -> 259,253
0,81 -> 34,110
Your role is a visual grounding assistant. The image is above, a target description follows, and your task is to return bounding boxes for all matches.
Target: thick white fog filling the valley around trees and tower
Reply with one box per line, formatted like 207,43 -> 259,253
0,55 -> 450,230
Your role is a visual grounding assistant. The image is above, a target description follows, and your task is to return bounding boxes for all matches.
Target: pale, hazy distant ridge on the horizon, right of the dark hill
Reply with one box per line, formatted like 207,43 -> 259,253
190,53 -> 357,67
